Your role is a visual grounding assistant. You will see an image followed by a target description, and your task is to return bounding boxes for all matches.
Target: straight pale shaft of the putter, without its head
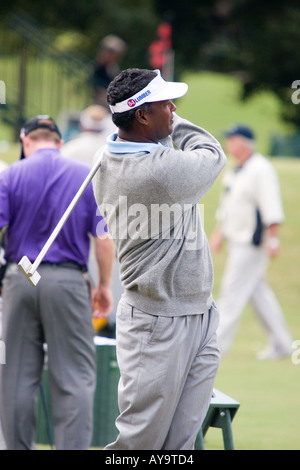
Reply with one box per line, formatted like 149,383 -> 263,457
29,151 -> 103,274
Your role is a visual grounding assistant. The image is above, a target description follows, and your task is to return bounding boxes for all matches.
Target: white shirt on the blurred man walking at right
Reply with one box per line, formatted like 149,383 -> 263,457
216,153 -> 284,243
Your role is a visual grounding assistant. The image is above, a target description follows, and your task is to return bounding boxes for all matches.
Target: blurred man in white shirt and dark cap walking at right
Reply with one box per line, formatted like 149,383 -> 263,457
211,126 -> 292,359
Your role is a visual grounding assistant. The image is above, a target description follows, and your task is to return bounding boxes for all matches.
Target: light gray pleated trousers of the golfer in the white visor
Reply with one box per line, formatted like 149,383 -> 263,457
105,300 -> 219,450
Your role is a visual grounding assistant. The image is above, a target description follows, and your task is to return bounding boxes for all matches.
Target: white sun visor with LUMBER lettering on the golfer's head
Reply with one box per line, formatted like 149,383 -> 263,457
109,70 -> 188,113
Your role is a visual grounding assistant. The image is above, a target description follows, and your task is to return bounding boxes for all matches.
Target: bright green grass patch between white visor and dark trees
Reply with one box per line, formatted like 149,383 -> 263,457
175,72 -> 291,153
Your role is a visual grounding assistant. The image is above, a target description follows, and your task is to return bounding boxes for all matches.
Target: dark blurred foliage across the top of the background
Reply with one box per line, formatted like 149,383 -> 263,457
0,0 -> 300,147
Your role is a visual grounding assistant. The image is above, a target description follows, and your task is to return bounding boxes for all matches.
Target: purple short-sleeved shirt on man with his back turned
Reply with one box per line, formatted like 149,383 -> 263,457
0,149 -> 107,265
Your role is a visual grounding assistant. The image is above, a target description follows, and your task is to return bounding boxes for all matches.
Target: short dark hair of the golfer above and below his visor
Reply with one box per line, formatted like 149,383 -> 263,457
107,69 -> 157,131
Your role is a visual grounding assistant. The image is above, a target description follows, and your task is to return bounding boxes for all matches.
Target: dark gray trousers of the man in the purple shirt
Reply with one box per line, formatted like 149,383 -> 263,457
0,265 -> 96,450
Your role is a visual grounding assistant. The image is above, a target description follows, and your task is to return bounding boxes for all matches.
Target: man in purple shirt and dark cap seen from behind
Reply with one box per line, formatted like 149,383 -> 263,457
0,116 -> 114,450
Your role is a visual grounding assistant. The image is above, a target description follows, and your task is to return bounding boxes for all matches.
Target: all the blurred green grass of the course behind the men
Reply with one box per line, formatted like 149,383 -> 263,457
0,74 -> 300,450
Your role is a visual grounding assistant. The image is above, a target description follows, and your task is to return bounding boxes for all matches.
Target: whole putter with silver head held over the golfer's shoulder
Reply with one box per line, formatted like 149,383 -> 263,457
18,150 -> 103,287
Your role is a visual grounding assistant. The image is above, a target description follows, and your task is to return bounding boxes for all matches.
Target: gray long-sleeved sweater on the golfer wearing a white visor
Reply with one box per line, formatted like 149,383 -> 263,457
93,115 -> 226,316
